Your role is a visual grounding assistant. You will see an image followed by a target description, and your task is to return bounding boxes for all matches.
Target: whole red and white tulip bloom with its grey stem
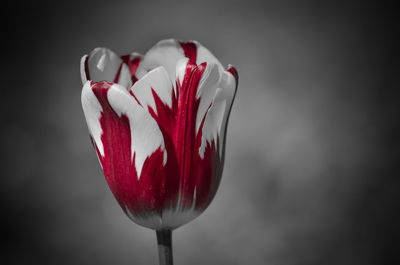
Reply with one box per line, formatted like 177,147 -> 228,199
81,40 -> 238,264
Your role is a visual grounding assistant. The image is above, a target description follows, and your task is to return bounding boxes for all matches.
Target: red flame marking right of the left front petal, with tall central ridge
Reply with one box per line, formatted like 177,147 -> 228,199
149,62 -> 221,211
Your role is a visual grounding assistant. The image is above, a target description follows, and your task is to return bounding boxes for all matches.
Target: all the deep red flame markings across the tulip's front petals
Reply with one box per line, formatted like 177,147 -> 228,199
92,56 -> 222,225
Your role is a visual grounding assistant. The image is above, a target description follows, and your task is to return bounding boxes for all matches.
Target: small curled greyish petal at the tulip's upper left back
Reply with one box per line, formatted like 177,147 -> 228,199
81,48 -> 132,88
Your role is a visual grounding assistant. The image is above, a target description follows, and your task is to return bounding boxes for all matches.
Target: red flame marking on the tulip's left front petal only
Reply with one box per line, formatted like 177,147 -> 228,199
92,82 -> 176,215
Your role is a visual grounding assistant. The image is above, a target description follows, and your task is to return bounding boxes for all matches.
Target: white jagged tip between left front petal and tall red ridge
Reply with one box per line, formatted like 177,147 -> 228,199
130,66 -> 173,114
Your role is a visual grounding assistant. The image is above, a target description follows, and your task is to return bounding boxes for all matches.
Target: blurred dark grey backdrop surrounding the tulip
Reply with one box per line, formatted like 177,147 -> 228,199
0,0 -> 400,265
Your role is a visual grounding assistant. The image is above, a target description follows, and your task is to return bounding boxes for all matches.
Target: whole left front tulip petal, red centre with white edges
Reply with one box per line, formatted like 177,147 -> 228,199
82,81 -> 178,229
